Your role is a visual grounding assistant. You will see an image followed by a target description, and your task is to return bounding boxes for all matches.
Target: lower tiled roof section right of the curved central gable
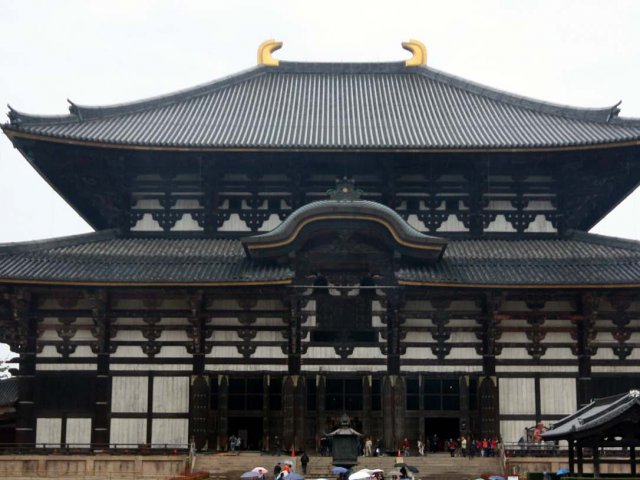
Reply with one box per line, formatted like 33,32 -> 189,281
396,232 -> 640,286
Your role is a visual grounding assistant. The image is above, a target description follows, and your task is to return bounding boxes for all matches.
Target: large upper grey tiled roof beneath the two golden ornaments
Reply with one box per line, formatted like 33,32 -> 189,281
4,62 -> 640,149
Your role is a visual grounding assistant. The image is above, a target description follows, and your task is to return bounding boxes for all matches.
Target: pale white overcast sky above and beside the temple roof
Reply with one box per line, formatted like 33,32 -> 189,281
0,0 -> 640,251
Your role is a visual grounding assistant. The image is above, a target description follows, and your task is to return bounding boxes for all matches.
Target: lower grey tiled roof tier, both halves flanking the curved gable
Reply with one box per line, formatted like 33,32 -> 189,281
0,230 -> 640,288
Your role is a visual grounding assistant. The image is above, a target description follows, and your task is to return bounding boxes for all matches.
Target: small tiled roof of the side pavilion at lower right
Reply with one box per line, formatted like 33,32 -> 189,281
542,390 -> 640,440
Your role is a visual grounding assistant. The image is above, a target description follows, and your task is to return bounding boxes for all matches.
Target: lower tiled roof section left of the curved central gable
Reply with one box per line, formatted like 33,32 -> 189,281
0,231 -> 292,284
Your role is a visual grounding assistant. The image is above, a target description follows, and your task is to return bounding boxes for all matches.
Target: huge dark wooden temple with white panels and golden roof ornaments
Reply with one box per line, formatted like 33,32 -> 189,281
0,41 -> 640,451
